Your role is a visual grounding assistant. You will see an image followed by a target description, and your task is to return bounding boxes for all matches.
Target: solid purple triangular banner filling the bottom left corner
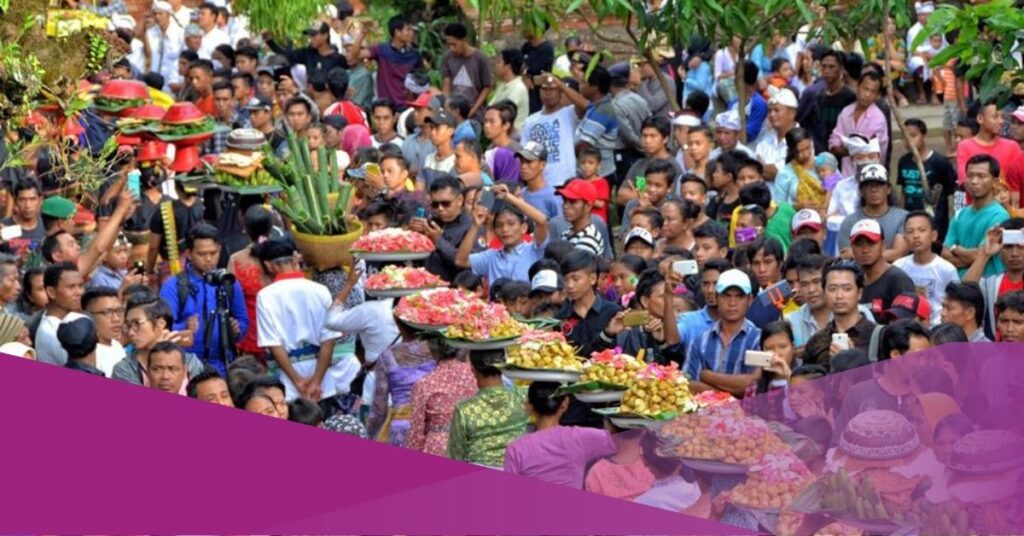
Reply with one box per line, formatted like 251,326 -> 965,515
0,357 -> 746,534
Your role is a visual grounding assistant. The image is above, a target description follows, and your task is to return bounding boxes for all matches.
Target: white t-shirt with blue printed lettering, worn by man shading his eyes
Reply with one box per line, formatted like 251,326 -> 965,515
520,106 -> 579,188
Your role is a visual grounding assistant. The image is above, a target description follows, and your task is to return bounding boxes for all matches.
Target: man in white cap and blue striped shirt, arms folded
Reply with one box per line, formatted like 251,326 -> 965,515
683,269 -> 761,397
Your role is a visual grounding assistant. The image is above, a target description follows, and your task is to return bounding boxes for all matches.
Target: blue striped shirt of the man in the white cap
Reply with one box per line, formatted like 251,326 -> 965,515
683,320 -> 761,381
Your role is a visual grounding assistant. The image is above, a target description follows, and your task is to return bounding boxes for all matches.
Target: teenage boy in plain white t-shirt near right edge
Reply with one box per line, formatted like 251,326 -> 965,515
893,210 -> 959,325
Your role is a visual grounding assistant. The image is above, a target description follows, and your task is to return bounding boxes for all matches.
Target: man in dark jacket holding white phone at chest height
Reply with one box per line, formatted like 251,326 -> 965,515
804,260 -> 876,367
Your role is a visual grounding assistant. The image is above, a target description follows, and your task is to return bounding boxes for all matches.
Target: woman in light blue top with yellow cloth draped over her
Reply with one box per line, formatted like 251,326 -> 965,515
772,128 -> 825,211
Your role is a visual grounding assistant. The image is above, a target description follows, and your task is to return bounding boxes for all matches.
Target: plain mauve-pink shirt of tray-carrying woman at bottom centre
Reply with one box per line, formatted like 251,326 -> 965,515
505,426 -> 615,490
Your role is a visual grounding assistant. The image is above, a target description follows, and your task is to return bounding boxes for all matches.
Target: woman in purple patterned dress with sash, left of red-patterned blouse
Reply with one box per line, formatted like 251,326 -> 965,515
367,319 -> 437,447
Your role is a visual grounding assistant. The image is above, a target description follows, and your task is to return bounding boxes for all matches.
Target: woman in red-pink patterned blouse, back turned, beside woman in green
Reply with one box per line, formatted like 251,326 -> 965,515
406,342 -> 476,456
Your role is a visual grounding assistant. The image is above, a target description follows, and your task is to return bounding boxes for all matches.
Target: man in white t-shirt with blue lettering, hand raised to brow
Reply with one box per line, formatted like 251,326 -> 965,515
524,71 -> 579,188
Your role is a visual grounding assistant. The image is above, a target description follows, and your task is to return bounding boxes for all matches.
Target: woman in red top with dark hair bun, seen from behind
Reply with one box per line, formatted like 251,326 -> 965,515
227,205 -> 273,360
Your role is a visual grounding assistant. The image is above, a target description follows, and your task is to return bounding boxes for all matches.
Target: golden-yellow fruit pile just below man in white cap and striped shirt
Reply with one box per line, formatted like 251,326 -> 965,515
621,363 -> 693,417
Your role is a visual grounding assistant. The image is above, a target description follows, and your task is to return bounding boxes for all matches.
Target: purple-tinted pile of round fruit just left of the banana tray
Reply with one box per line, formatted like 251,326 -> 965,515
727,453 -> 814,509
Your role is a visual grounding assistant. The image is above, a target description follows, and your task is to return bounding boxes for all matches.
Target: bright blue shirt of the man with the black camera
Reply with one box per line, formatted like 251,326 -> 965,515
160,264 -> 249,375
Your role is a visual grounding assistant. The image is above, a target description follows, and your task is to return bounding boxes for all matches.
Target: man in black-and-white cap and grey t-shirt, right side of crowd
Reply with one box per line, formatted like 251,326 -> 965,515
839,164 -> 910,262
